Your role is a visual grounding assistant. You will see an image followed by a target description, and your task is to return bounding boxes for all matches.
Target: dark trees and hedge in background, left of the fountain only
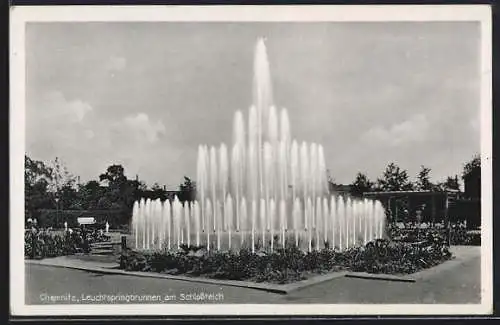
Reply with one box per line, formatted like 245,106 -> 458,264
24,155 -> 195,218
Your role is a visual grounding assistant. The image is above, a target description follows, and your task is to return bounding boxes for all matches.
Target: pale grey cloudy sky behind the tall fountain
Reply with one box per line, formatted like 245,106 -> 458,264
26,22 -> 480,189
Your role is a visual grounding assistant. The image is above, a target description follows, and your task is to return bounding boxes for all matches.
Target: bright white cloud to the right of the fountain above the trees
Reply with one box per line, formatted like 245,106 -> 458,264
362,114 -> 430,147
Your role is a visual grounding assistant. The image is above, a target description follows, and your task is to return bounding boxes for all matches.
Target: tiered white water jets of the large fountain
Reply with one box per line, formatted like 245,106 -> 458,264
132,39 -> 385,251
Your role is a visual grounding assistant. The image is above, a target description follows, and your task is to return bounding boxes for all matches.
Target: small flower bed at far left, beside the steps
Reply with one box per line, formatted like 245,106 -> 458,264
24,230 -> 109,259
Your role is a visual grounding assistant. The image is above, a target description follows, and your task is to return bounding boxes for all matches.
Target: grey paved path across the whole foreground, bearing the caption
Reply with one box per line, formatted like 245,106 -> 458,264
25,248 -> 481,304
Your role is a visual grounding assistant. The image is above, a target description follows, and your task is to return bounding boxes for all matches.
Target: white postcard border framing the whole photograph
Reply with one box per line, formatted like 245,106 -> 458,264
9,5 -> 493,316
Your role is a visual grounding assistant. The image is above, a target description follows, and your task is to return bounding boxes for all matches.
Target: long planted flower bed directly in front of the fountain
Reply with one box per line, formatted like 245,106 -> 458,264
119,239 -> 451,284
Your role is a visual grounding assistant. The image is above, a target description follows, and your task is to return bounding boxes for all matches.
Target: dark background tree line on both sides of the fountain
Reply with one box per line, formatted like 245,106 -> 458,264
24,155 -> 481,224
